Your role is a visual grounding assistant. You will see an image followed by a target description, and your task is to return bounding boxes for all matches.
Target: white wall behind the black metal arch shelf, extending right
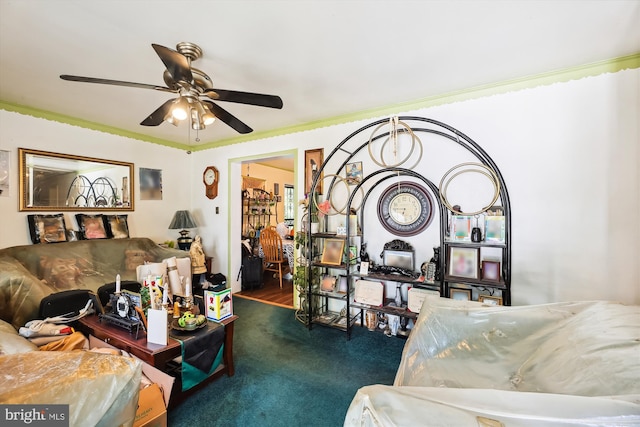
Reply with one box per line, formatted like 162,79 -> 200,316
194,69 -> 640,305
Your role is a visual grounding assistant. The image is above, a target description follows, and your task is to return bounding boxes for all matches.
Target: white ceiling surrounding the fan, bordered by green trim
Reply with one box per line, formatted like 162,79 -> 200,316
0,0 -> 640,150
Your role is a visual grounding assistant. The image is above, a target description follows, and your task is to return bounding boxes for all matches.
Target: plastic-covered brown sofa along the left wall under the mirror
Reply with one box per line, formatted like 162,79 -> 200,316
0,238 -> 189,329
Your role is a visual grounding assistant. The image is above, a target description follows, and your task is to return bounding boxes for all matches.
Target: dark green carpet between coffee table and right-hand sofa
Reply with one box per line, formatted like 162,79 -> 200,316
168,298 -> 405,427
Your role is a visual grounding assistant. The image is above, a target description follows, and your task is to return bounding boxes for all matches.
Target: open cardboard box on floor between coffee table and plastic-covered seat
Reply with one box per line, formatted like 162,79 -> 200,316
89,335 -> 175,427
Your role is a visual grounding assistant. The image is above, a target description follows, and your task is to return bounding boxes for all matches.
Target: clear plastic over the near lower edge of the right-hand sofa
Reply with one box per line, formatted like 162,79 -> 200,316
344,385 -> 640,427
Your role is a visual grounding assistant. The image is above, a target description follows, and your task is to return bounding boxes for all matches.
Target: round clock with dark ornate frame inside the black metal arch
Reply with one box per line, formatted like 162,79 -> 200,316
378,181 -> 433,237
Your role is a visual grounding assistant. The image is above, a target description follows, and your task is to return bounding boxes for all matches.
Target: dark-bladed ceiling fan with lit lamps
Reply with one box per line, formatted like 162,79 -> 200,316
60,42 -> 282,133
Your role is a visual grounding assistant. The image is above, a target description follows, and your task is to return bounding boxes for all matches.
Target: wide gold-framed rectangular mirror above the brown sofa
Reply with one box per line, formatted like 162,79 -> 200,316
18,148 -> 134,212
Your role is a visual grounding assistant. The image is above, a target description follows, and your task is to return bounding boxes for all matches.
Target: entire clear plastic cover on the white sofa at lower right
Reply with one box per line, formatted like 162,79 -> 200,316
345,298 -> 640,426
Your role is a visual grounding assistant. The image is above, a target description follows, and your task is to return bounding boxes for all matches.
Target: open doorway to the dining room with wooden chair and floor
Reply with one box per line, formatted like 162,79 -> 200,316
230,150 -> 297,308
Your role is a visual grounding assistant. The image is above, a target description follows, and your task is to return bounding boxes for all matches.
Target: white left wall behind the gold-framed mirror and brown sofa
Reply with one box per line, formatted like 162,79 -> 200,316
0,110 -> 190,248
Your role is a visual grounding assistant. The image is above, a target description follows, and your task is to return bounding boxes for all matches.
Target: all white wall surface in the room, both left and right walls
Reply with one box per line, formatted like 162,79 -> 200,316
0,69 -> 640,305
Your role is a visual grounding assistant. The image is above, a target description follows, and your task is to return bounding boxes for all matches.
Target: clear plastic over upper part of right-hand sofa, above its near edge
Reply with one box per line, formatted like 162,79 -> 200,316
394,298 -> 640,396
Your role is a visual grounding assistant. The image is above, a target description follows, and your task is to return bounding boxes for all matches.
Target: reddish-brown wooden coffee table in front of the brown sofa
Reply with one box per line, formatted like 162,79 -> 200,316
76,315 -> 238,406
